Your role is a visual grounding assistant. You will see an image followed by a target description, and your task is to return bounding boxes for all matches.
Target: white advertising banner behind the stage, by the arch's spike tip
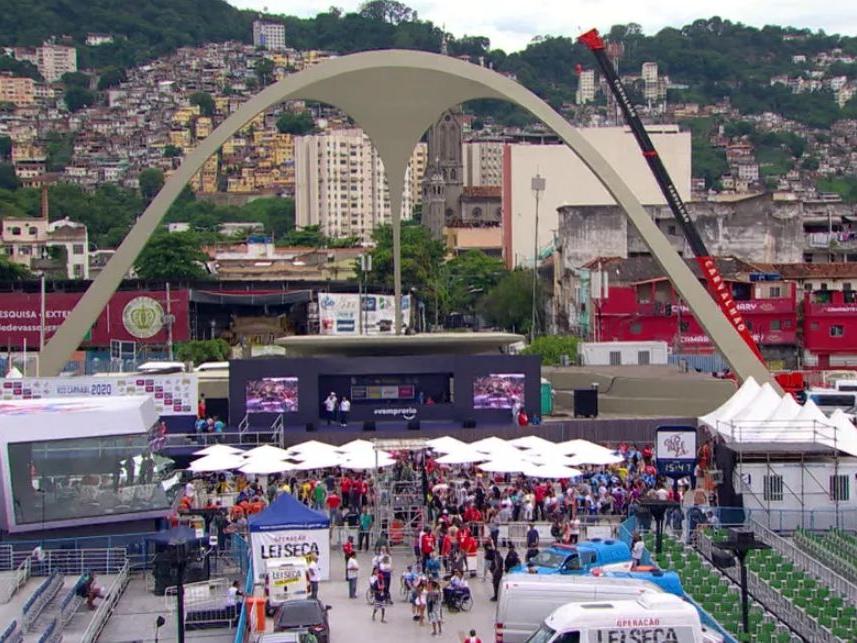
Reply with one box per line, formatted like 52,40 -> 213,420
318,293 -> 411,335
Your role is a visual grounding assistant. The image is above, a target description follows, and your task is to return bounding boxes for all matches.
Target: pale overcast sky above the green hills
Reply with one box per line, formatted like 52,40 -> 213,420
228,0 -> 857,51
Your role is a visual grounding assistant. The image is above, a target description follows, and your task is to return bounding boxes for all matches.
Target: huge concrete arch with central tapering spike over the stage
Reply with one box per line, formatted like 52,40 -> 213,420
39,50 -> 771,382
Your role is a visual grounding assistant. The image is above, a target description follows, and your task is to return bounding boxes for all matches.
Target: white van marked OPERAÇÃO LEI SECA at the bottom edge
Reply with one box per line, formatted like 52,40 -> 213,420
527,592 -> 723,643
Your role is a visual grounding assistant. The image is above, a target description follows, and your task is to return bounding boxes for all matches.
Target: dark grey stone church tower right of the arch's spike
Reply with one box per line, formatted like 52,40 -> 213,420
423,107 -> 464,239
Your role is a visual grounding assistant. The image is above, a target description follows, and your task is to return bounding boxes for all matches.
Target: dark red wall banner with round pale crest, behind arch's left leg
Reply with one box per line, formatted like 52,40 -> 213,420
0,290 -> 190,348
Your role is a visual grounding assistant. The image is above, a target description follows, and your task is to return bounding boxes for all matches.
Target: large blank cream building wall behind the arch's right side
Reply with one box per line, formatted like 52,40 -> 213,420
503,125 -> 691,265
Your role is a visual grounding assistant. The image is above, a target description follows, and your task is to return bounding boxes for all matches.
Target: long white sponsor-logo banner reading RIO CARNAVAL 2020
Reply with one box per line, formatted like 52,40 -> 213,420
0,373 -> 199,417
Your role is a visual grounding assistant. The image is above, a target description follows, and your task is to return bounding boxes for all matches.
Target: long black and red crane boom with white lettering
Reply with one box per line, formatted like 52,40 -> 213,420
578,29 -> 764,362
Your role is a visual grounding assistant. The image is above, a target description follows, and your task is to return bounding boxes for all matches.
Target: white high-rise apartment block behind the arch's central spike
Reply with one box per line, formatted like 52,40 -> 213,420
295,129 -> 426,242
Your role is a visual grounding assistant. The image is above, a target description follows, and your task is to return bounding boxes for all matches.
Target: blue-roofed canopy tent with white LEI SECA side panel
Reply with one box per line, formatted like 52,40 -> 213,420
249,493 -> 330,580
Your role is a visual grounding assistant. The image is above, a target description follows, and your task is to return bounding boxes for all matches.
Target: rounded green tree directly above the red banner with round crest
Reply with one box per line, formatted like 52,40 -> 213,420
134,232 -> 208,281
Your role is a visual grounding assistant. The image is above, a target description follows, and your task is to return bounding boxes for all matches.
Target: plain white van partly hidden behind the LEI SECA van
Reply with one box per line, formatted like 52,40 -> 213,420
494,574 -> 663,643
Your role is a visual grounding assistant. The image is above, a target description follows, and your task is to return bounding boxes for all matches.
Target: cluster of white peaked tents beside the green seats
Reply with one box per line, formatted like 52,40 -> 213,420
699,378 -> 857,456
